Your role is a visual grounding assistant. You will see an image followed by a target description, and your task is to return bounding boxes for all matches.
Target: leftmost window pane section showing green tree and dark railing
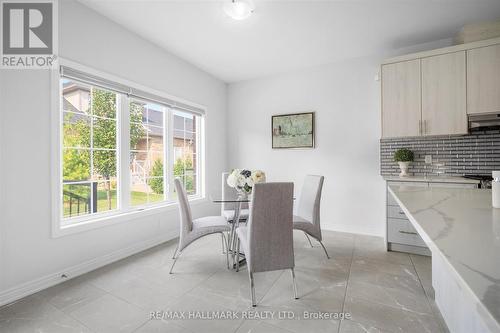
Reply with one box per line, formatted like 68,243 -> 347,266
62,79 -> 118,218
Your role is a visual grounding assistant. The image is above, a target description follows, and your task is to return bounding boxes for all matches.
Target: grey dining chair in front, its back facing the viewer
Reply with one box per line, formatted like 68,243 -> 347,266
236,183 -> 298,306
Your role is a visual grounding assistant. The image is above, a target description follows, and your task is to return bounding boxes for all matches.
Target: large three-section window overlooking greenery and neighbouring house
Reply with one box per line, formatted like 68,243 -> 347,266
59,68 -> 203,226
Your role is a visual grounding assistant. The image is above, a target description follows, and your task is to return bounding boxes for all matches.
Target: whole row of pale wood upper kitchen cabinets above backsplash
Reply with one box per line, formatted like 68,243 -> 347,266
381,38 -> 500,138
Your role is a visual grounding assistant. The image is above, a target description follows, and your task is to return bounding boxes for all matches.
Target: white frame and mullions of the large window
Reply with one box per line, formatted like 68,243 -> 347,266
51,58 -> 207,237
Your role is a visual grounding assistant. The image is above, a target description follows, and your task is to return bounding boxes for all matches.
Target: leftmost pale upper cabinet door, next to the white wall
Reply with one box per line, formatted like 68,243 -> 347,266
382,59 -> 421,138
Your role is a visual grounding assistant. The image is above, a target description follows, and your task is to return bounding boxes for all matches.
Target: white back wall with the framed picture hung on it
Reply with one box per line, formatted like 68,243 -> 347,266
227,39 -> 452,236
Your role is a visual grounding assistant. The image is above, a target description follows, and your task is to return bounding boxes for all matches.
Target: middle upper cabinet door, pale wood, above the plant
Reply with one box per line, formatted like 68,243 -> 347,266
422,51 -> 468,135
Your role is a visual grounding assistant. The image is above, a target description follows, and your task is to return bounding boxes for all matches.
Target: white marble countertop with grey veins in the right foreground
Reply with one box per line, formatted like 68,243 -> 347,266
389,185 -> 500,332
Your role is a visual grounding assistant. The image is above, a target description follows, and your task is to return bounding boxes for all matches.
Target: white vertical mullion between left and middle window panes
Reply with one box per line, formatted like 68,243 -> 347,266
117,95 -> 130,210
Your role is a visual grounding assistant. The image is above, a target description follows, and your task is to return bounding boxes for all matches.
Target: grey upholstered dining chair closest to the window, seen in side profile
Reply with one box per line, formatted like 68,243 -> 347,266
170,179 -> 230,274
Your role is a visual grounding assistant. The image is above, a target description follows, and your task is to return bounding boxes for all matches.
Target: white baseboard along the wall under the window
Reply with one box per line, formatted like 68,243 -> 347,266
0,231 -> 178,306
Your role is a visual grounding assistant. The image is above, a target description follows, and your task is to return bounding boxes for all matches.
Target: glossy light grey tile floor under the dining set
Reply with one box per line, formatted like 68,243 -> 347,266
0,232 -> 447,333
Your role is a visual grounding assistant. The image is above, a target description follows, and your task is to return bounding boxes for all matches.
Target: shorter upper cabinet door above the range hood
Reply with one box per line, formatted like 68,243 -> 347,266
467,45 -> 500,114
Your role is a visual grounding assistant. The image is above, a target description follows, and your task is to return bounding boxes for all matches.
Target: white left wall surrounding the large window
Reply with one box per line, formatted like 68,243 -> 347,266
0,1 -> 226,301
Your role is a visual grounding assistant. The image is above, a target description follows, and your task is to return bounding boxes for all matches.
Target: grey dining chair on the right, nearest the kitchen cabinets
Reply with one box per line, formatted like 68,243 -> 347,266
293,175 -> 330,259
